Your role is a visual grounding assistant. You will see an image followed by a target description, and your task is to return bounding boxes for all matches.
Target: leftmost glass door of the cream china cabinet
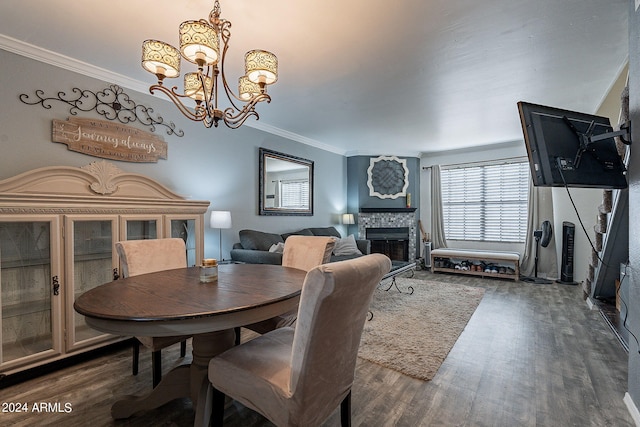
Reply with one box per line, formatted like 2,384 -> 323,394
0,217 -> 61,372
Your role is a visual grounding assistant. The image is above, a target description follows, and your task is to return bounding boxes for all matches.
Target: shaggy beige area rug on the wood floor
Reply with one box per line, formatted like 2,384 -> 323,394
358,278 -> 484,381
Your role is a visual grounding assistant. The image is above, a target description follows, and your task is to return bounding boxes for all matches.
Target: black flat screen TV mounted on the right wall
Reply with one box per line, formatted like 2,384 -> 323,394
518,102 -> 627,189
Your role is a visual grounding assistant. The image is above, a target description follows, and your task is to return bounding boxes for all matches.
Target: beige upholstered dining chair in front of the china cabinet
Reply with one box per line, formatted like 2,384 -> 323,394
116,238 -> 189,387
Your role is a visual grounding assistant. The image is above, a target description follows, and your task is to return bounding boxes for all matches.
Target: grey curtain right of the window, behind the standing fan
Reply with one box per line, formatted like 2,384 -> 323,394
520,181 -> 558,279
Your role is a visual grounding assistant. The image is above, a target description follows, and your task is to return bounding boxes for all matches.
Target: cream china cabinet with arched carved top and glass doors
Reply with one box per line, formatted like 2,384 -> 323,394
0,161 -> 209,377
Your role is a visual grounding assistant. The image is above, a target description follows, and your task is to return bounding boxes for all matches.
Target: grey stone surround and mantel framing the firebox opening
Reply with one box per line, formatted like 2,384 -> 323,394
358,208 -> 418,261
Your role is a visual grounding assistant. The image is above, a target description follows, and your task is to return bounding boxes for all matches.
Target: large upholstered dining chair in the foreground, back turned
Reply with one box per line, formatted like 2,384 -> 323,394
205,254 -> 391,427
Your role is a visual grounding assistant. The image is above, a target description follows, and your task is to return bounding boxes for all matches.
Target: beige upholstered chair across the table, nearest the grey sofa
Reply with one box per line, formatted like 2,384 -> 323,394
236,235 -> 336,344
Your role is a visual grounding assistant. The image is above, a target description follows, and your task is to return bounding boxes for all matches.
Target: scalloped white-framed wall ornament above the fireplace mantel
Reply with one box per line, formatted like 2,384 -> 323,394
367,156 -> 409,199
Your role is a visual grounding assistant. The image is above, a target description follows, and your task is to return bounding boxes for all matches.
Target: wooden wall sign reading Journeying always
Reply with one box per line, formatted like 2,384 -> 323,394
52,117 -> 167,163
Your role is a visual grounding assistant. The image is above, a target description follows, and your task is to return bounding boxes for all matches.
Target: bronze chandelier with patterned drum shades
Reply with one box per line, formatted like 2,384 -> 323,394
142,0 -> 278,129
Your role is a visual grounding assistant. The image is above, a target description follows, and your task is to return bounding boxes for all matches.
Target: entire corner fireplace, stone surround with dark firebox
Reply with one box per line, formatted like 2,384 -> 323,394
358,208 -> 420,261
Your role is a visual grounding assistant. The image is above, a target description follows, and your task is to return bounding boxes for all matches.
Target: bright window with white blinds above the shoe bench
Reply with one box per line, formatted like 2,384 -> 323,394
441,161 -> 529,242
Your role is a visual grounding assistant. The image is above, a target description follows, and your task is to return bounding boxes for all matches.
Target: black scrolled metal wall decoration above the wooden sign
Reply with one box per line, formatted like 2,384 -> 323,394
19,85 -> 184,136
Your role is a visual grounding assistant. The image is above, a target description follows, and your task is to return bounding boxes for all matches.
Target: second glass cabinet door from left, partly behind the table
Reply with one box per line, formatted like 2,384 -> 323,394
65,216 -> 117,349
